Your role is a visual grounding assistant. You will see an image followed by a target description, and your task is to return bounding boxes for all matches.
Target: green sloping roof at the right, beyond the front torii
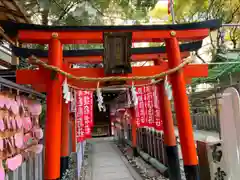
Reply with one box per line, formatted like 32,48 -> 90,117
192,50 -> 240,84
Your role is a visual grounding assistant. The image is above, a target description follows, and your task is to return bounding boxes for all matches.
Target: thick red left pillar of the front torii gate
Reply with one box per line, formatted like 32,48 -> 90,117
44,34 -> 63,180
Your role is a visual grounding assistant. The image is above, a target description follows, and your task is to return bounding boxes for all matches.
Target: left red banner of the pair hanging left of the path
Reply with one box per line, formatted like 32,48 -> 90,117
75,90 -> 85,142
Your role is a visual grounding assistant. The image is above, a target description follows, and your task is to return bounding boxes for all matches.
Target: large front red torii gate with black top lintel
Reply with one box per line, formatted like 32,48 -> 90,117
0,20 -> 220,180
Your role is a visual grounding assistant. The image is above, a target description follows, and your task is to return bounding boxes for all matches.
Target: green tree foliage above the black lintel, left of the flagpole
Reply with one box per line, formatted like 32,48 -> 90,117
20,0 -> 157,25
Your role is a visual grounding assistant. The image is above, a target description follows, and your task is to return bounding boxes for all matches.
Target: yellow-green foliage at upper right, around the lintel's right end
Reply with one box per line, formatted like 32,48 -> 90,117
151,0 -> 240,50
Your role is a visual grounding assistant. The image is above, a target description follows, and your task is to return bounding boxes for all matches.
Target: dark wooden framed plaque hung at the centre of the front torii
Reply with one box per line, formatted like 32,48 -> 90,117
103,32 -> 132,75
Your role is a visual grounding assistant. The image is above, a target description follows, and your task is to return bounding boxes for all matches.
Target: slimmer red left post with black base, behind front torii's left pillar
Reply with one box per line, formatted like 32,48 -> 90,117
61,101 -> 69,178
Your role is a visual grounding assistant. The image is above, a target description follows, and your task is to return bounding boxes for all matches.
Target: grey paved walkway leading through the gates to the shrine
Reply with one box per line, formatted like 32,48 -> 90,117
91,138 -> 141,180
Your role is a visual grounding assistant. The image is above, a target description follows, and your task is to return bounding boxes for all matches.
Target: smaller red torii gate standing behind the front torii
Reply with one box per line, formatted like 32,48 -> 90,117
15,47 -> 201,180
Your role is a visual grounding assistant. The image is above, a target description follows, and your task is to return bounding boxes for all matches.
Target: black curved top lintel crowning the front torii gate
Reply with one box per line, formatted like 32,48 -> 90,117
0,20 -> 221,36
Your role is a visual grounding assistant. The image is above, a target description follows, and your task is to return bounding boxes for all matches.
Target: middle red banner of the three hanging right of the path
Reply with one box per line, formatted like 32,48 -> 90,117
145,86 -> 155,128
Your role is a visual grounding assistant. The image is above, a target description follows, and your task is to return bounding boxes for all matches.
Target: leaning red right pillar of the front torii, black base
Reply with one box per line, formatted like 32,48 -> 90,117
165,35 -> 199,180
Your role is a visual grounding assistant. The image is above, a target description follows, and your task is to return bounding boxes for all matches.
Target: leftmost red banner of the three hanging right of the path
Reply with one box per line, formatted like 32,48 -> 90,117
135,87 -> 146,127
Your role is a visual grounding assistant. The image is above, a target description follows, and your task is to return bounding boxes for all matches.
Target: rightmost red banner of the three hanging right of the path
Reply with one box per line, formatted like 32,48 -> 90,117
153,85 -> 163,131
